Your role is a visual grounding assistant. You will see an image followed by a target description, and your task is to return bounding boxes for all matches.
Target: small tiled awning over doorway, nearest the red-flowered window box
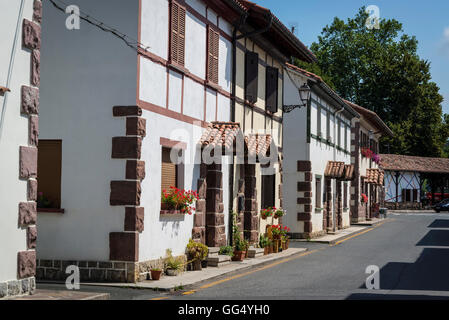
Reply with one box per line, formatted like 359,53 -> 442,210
200,122 -> 240,150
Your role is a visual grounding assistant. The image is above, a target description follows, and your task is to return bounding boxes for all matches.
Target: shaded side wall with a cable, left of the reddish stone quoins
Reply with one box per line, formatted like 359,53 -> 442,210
37,0 -> 138,261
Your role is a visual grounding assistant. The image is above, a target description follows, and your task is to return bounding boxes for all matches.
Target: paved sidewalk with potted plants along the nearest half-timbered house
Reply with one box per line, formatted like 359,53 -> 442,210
82,248 -> 307,291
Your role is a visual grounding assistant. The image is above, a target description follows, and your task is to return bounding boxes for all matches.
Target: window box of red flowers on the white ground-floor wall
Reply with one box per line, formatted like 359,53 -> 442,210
161,187 -> 198,216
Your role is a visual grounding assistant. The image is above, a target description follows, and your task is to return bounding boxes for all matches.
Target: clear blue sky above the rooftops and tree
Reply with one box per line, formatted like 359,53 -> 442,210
253,0 -> 449,113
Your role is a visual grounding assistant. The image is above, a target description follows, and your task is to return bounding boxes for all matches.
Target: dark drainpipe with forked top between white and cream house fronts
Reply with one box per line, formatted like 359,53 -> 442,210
229,13 -> 274,244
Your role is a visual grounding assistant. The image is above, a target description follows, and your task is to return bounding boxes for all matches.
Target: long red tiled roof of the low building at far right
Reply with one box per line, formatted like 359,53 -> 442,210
380,154 -> 449,173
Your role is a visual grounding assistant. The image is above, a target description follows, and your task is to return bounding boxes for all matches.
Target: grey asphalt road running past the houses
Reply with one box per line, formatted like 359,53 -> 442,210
38,213 -> 449,300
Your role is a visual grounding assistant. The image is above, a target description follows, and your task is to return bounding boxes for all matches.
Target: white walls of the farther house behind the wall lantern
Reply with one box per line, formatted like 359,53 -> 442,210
283,71 -> 351,233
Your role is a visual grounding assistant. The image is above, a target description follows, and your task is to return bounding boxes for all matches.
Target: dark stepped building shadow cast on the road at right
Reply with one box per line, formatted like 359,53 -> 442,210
347,220 -> 449,300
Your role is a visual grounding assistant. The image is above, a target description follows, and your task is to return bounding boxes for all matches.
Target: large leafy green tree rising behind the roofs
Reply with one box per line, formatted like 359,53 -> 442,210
298,7 -> 449,157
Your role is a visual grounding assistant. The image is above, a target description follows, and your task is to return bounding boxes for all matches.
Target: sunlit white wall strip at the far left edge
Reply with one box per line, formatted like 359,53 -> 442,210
0,0 -> 33,282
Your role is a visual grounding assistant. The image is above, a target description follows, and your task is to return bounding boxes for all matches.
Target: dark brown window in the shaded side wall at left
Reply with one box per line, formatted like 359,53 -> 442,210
37,140 -> 62,209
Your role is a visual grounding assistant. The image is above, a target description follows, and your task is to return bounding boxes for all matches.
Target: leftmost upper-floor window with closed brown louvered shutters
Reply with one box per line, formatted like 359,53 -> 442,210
170,1 -> 186,66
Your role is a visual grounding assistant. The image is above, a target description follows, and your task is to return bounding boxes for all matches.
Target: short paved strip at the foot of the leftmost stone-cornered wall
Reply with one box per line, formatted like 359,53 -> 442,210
10,289 -> 109,300
